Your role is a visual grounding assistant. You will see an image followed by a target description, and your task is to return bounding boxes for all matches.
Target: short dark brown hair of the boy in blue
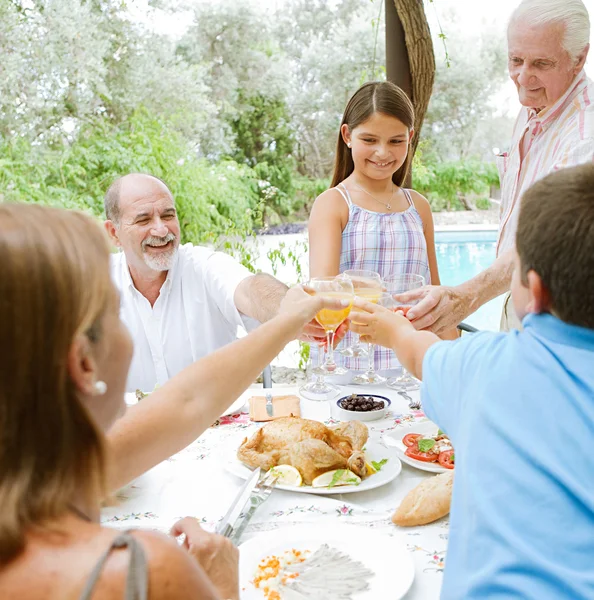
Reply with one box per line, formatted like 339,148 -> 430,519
516,164 -> 594,329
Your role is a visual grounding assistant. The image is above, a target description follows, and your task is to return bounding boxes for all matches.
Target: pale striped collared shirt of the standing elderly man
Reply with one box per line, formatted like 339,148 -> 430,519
497,71 -> 594,255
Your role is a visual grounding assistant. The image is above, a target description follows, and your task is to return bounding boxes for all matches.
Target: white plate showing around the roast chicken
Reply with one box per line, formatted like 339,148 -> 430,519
226,440 -> 402,496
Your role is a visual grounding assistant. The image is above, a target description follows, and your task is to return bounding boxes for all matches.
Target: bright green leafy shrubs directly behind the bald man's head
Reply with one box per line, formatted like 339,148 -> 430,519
0,109 -> 260,243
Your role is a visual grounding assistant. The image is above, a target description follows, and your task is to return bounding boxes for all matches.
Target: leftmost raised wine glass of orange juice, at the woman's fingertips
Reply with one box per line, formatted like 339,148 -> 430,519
308,275 -> 354,375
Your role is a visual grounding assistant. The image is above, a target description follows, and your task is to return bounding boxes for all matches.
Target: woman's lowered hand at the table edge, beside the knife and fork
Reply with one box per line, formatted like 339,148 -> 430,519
170,517 -> 239,600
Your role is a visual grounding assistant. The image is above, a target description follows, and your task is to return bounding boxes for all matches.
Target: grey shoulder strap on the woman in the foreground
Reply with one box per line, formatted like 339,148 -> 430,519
80,532 -> 148,600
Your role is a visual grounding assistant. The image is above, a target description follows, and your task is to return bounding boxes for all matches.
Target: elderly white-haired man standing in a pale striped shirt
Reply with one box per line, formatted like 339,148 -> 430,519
401,0 -> 594,334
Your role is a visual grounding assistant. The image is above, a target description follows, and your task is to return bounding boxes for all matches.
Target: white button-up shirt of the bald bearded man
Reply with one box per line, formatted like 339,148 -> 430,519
111,244 -> 251,392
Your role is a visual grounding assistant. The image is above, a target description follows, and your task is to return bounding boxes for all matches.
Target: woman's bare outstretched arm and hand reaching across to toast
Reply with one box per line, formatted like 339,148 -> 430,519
107,288 -> 342,490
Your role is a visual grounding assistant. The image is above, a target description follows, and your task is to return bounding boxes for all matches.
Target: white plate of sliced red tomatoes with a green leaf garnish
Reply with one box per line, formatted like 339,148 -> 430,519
384,421 -> 456,473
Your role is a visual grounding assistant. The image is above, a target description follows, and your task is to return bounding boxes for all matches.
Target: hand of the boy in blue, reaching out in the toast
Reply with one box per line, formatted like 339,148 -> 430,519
350,298 -> 414,348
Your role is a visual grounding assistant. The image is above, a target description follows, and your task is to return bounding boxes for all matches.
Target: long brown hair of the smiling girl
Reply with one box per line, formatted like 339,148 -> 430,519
330,81 -> 415,187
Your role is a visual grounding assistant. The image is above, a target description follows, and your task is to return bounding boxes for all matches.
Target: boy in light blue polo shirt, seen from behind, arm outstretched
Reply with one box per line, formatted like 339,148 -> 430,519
353,165 -> 594,600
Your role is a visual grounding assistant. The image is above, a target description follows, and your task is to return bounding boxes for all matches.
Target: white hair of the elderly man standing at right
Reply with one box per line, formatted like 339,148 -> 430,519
509,0 -> 590,60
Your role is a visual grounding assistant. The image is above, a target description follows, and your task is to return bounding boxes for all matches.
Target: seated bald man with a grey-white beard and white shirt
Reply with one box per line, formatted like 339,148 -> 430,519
105,173 -> 325,392
